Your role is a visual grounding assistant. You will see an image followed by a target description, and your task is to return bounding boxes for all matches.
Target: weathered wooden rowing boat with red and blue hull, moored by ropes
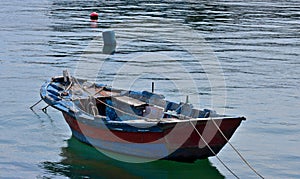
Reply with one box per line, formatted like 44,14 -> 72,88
40,71 -> 246,162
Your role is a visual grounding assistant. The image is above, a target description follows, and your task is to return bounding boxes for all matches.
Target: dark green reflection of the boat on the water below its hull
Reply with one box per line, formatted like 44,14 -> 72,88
41,137 -> 224,178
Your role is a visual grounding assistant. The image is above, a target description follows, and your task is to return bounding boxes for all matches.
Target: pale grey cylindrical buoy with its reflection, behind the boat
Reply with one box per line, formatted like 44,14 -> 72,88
102,30 -> 117,54
